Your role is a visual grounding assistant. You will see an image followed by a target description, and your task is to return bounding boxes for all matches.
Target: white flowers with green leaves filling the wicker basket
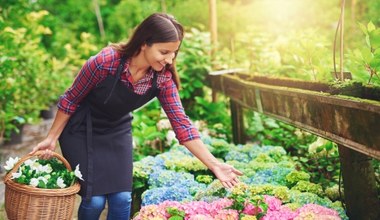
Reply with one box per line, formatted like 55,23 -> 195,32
4,153 -> 83,189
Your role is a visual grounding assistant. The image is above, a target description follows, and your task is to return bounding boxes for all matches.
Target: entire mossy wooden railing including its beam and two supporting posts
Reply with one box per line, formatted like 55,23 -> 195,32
208,70 -> 380,219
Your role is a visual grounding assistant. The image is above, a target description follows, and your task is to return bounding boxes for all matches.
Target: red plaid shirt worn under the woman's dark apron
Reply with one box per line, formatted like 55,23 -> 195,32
58,47 -> 200,144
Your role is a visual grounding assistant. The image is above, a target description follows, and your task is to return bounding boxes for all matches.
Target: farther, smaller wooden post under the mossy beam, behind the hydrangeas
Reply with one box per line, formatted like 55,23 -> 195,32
230,99 -> 246,144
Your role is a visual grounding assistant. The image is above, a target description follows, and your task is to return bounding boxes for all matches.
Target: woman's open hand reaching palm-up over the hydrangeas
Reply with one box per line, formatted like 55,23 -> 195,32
211,163 -> 243,188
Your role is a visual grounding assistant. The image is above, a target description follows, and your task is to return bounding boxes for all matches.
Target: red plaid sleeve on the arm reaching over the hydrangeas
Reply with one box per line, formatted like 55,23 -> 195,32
157,71 -> 200,144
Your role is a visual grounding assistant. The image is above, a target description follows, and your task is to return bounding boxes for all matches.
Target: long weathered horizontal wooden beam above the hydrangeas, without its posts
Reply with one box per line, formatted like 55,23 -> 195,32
209,75 -> 380,159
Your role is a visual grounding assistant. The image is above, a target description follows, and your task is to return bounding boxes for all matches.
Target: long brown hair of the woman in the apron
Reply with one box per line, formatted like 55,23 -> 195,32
110,13 -> 184,89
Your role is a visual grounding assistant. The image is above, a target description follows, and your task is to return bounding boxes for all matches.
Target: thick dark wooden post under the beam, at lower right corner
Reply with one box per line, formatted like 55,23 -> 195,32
338,145 -> 380,220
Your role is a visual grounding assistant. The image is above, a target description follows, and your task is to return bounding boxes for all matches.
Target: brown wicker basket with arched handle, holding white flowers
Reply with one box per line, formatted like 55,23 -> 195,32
4,151 -> 80,220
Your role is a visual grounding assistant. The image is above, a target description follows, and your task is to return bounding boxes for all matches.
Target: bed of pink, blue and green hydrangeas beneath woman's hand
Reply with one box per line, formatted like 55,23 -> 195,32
134,138 -> 348,220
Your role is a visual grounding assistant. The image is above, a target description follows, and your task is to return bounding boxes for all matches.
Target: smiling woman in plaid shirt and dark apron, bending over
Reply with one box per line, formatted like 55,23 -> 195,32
31,13 -> 242,220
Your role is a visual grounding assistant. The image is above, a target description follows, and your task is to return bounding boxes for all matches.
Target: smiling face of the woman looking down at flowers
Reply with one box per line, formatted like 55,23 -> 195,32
141,41 -> 181,71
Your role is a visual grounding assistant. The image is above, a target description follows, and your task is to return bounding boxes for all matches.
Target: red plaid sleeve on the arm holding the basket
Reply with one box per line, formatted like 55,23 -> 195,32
57,48 -> 113,115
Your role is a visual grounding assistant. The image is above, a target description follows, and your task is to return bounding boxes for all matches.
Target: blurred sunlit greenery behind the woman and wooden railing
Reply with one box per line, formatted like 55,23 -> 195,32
0,0 -> 380,150
